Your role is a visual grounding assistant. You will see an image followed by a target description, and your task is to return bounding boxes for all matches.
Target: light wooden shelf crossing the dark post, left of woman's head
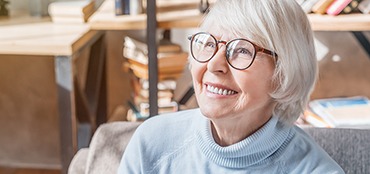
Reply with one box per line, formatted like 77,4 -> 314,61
88,0 -> 201,30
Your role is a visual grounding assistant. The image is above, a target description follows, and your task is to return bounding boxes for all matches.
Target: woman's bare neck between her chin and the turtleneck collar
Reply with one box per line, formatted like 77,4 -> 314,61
211,112 -> 272,146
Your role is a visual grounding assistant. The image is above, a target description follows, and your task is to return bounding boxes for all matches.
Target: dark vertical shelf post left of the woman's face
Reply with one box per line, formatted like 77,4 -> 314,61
146,0 -> 158,116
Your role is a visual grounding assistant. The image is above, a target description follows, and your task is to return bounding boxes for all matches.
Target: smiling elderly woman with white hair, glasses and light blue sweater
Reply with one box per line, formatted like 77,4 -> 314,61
119,0 -> 344,174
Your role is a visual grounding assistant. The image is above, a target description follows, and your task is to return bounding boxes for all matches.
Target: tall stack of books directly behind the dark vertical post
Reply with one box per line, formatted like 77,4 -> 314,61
123,36 -> 188,121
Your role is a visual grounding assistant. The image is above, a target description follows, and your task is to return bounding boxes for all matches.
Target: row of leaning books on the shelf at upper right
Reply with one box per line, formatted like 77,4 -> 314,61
297,0 -> 370,16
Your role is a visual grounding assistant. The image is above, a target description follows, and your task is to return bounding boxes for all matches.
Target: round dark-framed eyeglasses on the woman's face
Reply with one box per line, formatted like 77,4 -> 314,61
188,32 -> 277,70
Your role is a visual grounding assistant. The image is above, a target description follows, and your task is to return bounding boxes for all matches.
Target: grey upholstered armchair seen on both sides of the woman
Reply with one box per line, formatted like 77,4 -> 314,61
68,122 -> 370,174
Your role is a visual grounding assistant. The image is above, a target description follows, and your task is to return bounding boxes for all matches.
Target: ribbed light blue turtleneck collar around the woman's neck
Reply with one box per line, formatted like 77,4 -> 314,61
197,113 -> 292,168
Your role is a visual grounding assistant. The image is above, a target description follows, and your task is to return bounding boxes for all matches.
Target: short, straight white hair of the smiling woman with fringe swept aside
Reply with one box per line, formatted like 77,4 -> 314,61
200,0 -> 318,125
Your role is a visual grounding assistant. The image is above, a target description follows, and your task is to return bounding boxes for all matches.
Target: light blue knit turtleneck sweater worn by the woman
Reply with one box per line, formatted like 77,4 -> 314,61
118,109 -> 344,174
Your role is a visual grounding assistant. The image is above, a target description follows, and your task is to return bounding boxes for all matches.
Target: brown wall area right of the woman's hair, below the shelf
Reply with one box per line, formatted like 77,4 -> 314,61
312,32 -> 370,99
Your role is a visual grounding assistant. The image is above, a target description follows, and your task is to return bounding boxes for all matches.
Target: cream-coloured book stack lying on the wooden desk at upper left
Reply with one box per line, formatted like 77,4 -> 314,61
48,0 -> 95,23
